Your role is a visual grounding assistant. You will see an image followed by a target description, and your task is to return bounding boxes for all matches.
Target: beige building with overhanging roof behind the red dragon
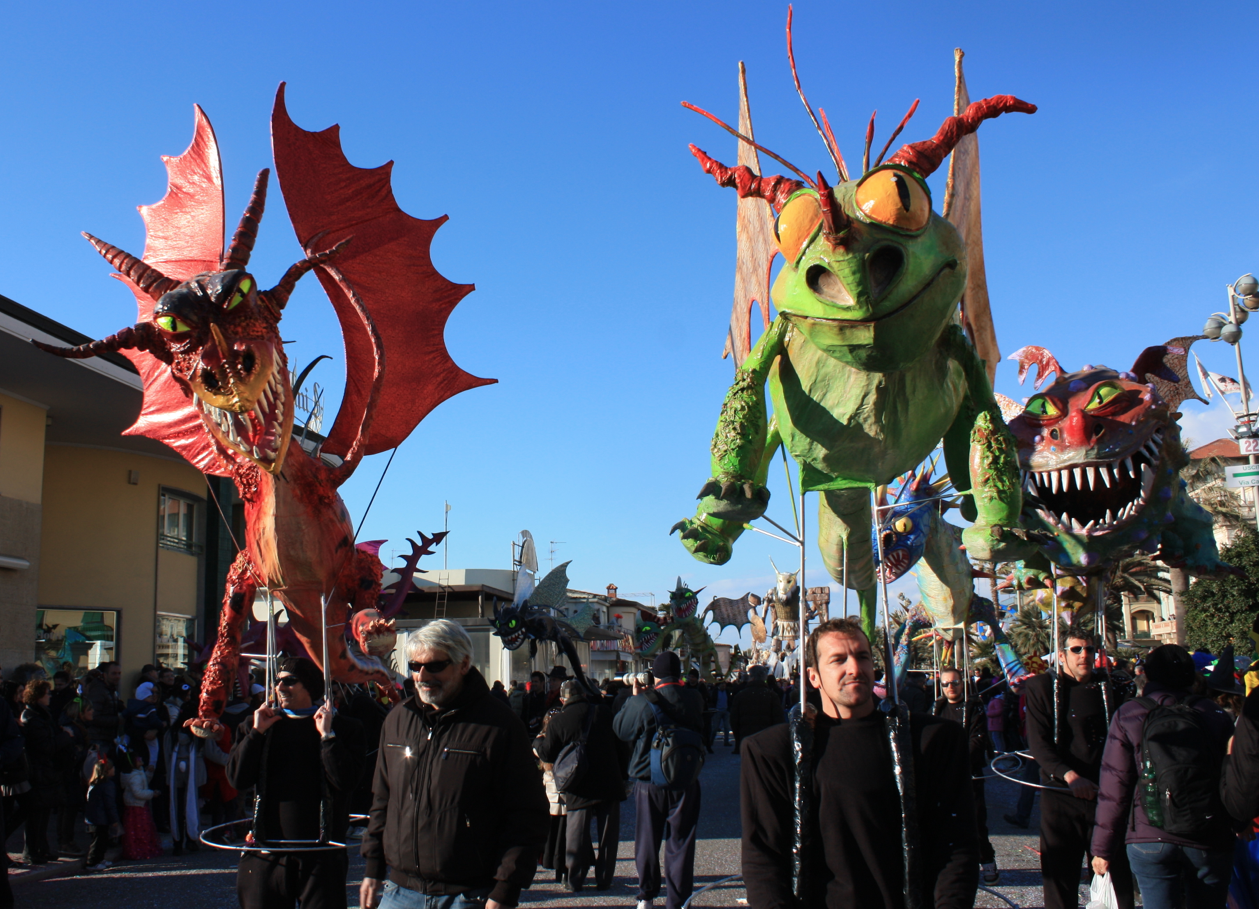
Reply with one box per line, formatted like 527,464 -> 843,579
0,297 -> 208,695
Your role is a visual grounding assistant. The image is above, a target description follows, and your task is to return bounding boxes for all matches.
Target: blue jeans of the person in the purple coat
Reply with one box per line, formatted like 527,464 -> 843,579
1128,842 -> 1233,909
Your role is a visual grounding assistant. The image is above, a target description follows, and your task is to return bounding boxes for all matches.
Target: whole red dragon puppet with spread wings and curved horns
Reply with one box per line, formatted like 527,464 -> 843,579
37,84 -> 494,737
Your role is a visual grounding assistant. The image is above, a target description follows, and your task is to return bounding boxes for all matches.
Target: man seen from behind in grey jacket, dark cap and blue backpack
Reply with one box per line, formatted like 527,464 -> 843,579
613,651 -> 704,909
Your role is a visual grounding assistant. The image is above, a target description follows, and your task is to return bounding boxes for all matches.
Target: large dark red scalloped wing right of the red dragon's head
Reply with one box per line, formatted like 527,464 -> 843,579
271,83 -> 497,456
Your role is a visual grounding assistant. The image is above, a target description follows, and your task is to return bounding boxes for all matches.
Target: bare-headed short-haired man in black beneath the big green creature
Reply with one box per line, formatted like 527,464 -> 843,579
742,618 -> 980,909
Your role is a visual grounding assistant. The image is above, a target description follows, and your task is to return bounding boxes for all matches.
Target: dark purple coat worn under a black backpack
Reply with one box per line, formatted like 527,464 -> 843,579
1089,681 -> 1233,860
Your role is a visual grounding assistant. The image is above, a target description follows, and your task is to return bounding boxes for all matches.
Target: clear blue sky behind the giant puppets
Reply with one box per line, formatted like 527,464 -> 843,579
0,1 -> 1259,649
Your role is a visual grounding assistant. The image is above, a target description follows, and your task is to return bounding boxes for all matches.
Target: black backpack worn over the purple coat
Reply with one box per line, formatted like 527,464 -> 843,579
1137,697 -> 1224,841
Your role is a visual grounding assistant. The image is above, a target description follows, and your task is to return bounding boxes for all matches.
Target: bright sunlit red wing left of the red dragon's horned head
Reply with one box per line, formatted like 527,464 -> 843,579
115,107 -> 228,476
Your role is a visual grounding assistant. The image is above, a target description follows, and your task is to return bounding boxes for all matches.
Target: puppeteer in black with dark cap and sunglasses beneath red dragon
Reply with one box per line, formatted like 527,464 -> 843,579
227,657 -> 366,909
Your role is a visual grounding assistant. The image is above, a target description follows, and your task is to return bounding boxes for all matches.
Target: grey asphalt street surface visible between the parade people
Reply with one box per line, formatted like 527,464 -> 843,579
9,742 -> 1085,909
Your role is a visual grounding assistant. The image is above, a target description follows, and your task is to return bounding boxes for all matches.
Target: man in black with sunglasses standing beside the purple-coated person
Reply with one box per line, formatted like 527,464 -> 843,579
1026,626 -> 1133,909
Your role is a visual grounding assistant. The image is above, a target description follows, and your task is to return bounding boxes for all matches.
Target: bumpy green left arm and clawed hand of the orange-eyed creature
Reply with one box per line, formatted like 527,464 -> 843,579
670,319 -> 787,565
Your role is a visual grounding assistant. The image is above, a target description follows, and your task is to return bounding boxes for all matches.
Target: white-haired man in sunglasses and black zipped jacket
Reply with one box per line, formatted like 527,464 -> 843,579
359,619 -> 549,909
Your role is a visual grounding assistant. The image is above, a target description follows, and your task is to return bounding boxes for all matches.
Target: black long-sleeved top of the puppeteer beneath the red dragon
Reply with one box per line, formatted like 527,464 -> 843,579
227,715 -> 366,844
